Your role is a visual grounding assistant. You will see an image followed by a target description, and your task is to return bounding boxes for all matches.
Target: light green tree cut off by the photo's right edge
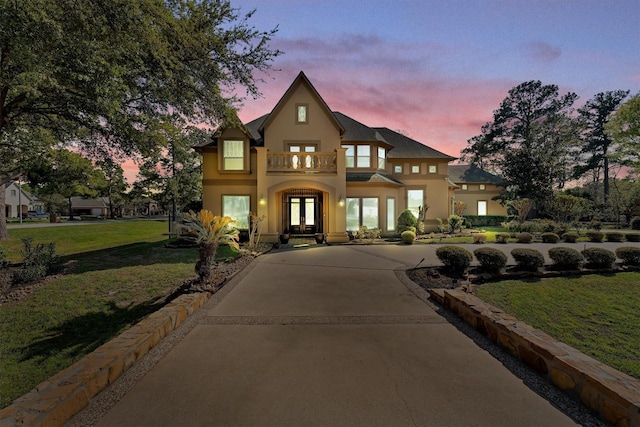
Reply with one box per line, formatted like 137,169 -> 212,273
605,93 -> 640,173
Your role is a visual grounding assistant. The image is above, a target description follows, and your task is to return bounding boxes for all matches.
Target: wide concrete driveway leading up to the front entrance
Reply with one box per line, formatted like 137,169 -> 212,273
87,245 -> 588,426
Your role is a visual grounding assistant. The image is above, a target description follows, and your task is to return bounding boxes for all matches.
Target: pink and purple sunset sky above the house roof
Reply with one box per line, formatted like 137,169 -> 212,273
232,0 -> 640,157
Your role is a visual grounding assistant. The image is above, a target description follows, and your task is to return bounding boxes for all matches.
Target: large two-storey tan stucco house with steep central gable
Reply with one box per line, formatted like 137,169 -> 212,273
195,72 -> 496,243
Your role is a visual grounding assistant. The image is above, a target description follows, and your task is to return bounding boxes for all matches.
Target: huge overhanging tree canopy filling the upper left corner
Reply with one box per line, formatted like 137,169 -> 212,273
0,0 -> 280,239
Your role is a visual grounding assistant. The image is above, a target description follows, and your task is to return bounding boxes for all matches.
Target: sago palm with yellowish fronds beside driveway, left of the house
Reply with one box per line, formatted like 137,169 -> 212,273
182,209 -> 239,282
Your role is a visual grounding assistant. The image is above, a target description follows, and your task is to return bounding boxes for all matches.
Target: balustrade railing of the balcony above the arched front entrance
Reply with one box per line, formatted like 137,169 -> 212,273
267,152 -> 337,173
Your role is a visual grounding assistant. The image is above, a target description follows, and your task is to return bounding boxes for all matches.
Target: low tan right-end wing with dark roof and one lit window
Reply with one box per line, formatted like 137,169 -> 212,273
449,165 -> 507,216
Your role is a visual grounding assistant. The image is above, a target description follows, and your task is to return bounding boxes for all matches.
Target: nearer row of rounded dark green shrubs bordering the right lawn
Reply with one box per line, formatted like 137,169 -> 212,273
436,245 -> 640,275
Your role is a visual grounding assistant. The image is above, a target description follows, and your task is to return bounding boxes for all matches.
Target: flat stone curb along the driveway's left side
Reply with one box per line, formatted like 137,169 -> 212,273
0,292 -> 211,426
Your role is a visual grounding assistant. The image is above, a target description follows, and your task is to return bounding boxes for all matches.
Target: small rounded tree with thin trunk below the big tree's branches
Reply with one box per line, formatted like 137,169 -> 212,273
27,149 -> 106,219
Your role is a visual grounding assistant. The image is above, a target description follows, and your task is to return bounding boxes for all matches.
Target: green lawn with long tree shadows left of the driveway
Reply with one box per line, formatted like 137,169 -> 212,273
0,221 -> 198,408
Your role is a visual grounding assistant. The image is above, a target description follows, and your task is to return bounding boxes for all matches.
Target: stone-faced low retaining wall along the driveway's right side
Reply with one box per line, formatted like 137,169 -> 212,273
429,289 -> 640,427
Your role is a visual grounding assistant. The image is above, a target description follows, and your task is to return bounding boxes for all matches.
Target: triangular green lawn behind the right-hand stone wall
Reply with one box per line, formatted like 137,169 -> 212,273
478,272 -> 640,379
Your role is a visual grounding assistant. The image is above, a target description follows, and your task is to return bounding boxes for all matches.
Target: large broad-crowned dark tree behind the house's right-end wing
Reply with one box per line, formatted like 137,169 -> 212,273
462,81 -> 577,204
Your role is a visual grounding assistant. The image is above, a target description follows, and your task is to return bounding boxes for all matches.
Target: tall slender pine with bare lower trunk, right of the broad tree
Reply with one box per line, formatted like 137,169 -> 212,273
574,90 -> 629,206
